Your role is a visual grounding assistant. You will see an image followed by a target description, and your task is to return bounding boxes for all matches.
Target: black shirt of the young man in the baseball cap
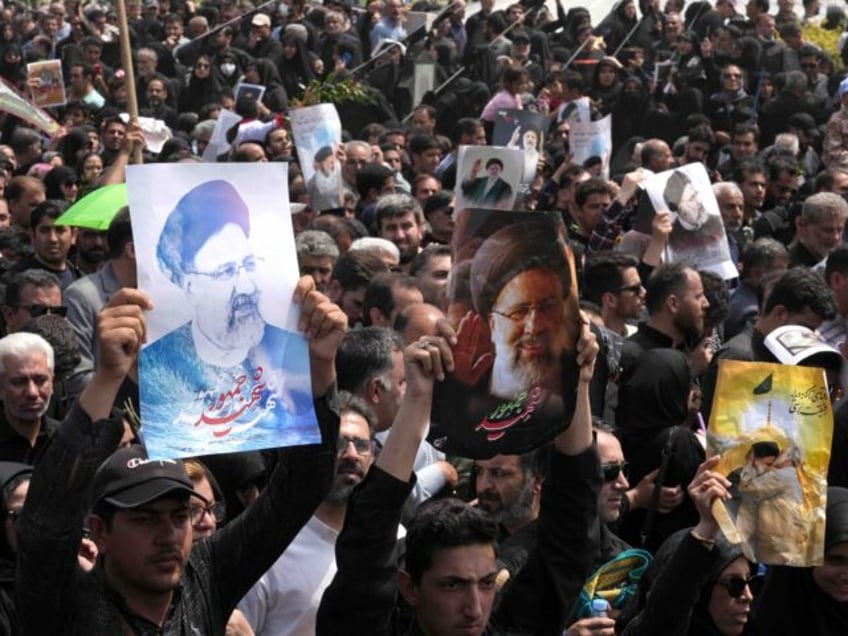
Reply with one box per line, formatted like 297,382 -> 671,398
17,393 -> 338,636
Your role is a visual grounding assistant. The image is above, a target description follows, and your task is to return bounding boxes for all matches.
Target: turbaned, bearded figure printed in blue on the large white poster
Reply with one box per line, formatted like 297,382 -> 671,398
140,180 -> 311,437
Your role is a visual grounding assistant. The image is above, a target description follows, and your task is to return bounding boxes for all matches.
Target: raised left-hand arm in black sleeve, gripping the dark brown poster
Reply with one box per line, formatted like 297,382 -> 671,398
316,336 -> 453,636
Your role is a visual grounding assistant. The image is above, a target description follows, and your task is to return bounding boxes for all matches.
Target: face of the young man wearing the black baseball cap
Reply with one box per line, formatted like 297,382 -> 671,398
89,497 -> 192,600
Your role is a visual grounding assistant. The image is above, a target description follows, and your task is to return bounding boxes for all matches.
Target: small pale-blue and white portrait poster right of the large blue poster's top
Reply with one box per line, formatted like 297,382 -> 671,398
290,104 -> 343,210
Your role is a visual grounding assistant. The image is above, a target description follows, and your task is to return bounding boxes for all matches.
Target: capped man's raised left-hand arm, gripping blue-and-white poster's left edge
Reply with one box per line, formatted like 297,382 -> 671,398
16,289 -> 150,634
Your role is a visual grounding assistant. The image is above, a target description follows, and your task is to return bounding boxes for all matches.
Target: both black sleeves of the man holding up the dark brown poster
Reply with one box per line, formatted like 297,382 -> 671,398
316,449 -> 600,636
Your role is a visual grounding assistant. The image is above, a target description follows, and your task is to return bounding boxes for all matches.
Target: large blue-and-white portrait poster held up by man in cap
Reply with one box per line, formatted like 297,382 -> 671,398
127,163 -> 320,459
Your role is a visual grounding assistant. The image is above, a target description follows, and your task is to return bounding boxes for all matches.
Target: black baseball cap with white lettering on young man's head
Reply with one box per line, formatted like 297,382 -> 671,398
93,444 -> 203,509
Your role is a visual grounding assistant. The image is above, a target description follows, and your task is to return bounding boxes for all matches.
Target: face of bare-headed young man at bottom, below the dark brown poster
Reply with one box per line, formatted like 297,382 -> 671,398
401,544 -> 497,636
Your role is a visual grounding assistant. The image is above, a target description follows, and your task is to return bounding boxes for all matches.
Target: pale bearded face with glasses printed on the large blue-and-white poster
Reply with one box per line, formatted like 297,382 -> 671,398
184,223 -> 265,351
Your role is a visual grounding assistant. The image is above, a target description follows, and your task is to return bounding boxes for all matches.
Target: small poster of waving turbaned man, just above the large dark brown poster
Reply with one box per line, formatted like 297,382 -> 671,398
456,146 -> 524,210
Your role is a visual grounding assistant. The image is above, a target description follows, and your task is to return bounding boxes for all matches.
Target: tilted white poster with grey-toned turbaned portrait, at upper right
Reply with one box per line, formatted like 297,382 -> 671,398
645,162 -> 739,280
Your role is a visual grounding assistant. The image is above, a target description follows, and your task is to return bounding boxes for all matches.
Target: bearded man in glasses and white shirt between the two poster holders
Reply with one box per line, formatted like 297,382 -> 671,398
239,391 -> 377,636
